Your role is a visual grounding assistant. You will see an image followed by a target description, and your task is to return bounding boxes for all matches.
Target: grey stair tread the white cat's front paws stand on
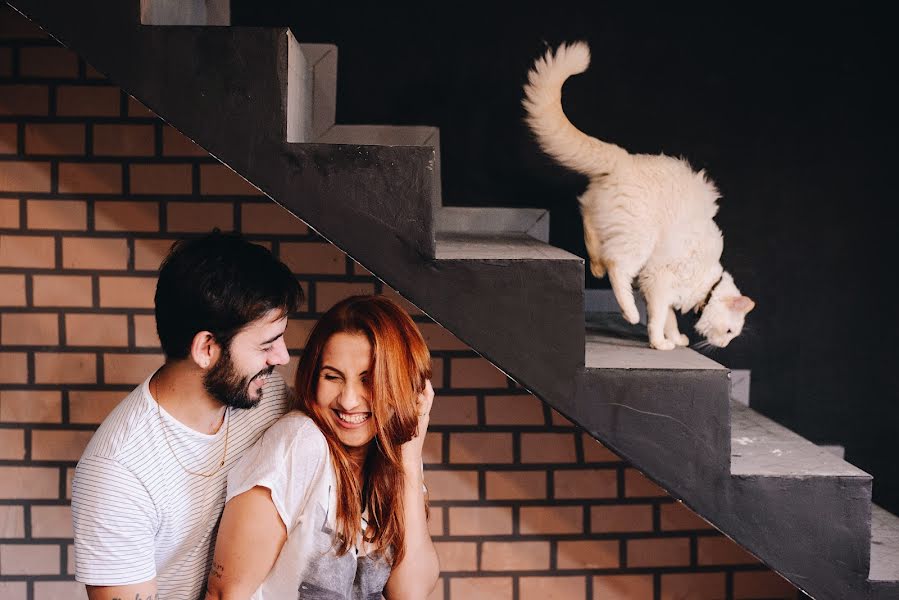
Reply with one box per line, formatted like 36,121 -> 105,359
584,313 -> 726,370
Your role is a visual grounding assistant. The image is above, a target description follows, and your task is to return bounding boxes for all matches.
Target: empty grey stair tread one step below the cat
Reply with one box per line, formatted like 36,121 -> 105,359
731,402 -> 871,479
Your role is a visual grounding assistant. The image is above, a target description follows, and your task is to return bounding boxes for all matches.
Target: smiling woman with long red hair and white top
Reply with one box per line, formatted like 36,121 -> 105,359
206,296 -> 439,600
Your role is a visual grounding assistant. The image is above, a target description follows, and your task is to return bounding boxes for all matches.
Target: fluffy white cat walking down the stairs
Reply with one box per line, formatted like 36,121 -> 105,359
523,42 -> 755,350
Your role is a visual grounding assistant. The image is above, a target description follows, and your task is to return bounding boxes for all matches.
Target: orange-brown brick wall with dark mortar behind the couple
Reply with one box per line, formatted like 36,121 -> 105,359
0,8 -> 796,600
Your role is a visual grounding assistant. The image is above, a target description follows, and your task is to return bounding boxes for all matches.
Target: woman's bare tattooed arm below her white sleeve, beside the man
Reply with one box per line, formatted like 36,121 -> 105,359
206,486 -> 287,600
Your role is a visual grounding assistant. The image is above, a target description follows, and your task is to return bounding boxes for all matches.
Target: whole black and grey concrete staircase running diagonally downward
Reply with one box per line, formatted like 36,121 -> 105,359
9,0 -> 899,599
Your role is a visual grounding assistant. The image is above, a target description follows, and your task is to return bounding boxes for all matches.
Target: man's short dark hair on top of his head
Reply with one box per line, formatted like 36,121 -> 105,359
156,230 -> 303,359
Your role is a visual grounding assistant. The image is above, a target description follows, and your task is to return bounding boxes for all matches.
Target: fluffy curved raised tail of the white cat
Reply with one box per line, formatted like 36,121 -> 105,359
522,42 -> 627,175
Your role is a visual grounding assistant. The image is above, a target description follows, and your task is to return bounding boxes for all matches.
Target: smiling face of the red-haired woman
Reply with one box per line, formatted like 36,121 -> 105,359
315,332 -> 375,448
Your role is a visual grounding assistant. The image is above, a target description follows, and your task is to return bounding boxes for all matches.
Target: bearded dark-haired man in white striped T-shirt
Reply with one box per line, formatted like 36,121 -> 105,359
72,231 -> 303,600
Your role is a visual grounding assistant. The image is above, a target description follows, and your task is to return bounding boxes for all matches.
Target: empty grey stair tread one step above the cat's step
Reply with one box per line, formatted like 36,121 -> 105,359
436,232 -> 584,262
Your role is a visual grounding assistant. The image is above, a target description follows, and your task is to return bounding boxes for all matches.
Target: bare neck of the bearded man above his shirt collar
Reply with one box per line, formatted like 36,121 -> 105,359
150,360 -> 225,434
